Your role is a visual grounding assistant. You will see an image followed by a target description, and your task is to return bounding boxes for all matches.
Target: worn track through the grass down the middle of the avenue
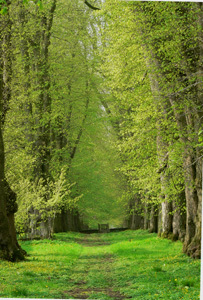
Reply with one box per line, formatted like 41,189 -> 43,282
62,235 -> 128,300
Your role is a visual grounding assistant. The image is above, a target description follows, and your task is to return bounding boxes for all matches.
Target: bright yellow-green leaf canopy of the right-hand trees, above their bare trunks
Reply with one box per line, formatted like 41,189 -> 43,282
100,1 -> 202,218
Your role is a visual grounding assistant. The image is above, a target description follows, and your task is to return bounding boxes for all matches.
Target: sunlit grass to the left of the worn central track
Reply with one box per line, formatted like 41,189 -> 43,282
0,235 -> 82,298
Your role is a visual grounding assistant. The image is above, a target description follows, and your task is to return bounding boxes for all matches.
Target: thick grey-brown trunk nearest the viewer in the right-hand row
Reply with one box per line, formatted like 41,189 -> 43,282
170,90 -> 203,257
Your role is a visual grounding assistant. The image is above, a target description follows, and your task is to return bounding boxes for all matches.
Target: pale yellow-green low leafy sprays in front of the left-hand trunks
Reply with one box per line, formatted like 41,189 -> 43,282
13,170 -> 82,236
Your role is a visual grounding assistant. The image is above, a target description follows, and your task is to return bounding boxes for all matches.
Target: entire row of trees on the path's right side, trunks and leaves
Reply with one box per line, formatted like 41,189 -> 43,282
101,1 -> 203,257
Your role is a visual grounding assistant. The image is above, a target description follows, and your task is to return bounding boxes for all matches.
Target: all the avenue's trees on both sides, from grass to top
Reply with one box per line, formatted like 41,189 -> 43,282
0,0 -> 203,260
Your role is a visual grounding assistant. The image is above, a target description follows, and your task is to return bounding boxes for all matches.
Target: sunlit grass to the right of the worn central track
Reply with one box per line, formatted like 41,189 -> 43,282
102,230 -> 200,300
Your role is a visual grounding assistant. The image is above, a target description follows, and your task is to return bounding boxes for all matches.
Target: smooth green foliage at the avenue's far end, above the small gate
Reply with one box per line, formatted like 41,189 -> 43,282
70,97 -> 125,228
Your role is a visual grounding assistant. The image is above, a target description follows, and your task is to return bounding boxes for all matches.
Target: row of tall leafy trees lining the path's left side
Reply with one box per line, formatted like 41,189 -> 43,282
0,0 -> 123,260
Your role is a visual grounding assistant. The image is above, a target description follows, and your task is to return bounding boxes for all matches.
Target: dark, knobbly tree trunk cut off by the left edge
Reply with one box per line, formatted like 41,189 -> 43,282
0,2 -> 25,261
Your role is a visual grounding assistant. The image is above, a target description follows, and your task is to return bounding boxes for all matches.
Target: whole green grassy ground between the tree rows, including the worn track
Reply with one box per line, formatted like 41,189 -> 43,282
0,230 -> 200,300
